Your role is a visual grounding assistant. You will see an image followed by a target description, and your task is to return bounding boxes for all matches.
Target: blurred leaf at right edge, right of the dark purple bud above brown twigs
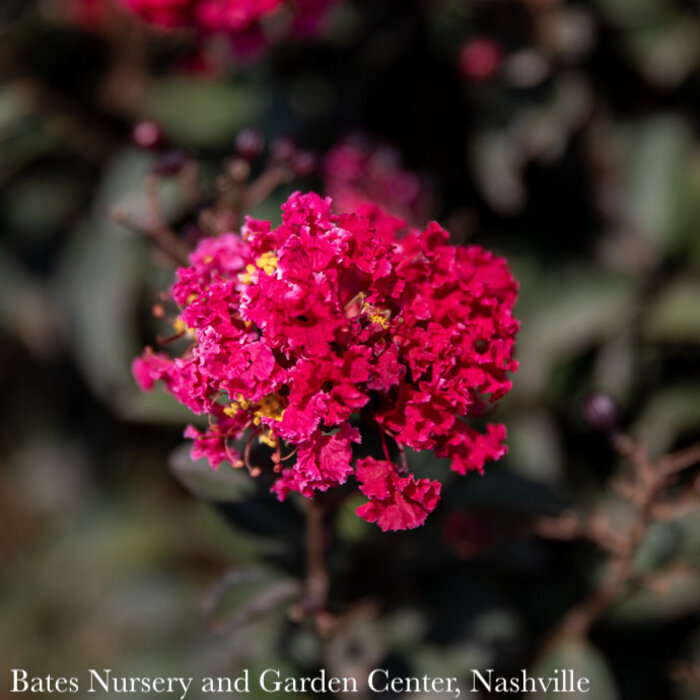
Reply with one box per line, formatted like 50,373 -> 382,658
633,384 -> 700,456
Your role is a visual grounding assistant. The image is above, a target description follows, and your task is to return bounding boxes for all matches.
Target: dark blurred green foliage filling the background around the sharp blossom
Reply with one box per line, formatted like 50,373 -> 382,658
0,0 -> 700,700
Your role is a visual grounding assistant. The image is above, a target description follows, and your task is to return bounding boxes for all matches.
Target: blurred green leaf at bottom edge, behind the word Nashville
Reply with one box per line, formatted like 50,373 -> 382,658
531,639 -> 619,700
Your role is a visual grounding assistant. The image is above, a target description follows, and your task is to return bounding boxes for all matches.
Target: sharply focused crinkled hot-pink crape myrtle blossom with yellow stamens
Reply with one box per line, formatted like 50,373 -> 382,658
133,192 -> 518,530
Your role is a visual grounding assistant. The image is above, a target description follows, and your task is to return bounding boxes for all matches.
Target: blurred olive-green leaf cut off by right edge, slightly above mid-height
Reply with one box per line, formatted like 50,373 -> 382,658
643,279 -> 700,343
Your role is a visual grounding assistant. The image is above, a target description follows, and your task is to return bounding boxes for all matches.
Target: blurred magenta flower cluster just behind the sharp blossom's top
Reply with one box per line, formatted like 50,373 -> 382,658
323,134 -> 432,221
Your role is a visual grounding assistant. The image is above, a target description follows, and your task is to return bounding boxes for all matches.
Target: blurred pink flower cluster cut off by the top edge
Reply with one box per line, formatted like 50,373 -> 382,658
121,0 -> 333,35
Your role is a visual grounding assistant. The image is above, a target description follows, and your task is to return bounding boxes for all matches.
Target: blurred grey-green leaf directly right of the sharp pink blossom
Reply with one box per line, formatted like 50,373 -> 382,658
513,270 -> 634,397
